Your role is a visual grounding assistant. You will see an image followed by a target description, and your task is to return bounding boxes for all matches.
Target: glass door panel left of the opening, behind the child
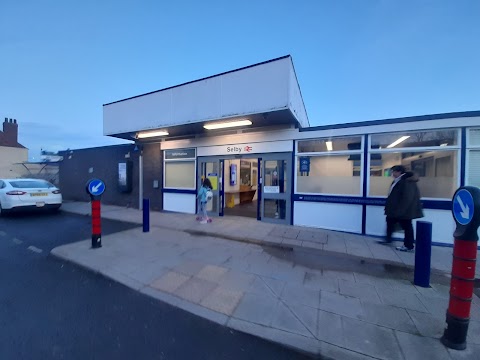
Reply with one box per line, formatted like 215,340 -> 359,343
197,158 -> 223,216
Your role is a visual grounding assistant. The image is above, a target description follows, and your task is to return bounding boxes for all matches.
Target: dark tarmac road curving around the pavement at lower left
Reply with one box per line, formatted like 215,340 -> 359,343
0,212 -> 307,360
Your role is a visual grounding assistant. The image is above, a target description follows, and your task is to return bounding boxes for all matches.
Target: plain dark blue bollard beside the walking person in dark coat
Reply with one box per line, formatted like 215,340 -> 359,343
413,221 -> 432,288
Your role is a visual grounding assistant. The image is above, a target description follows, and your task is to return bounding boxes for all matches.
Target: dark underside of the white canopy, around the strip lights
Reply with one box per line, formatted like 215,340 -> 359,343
109,109 -> 298,142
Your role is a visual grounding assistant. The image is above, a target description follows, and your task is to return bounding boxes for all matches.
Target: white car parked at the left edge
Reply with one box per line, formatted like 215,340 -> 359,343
0,179 -> 62,215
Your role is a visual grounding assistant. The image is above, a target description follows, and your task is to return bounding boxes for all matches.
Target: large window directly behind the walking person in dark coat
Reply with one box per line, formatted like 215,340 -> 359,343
369,129 -> 459,199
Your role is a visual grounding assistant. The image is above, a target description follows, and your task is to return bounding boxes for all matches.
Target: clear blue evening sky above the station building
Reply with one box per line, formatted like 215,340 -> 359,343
0,0 -> 480,159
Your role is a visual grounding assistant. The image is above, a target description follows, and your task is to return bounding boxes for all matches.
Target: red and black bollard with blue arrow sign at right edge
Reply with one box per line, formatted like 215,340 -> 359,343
440,186 -> 480,350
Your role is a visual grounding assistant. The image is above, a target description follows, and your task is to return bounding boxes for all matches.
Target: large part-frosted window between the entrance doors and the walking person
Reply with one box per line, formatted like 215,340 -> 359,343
296,136 -> 363,195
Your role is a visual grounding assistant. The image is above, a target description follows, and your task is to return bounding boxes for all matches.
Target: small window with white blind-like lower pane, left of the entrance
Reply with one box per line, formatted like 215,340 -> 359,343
164,149 -> 196,190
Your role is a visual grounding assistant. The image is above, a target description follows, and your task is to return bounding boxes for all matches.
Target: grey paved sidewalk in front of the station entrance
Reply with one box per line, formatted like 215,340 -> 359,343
52,202 -> 480,360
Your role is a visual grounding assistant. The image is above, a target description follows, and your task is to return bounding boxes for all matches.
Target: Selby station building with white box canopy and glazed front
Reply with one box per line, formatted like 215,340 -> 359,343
103,56 -> 480,245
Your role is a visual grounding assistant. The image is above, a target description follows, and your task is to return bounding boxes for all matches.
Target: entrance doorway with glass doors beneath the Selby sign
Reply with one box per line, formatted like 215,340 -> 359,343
198,153 -> 292,224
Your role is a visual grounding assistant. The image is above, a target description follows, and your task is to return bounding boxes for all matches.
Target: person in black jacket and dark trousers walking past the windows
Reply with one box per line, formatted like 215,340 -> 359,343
385,165 -> 423,252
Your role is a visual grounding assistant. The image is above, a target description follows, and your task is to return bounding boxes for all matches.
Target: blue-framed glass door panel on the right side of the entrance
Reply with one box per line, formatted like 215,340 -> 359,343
260,154 -> 292,225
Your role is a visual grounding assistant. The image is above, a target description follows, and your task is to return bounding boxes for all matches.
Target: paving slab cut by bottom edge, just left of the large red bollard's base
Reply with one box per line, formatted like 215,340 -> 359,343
396,331 -> 449,360
